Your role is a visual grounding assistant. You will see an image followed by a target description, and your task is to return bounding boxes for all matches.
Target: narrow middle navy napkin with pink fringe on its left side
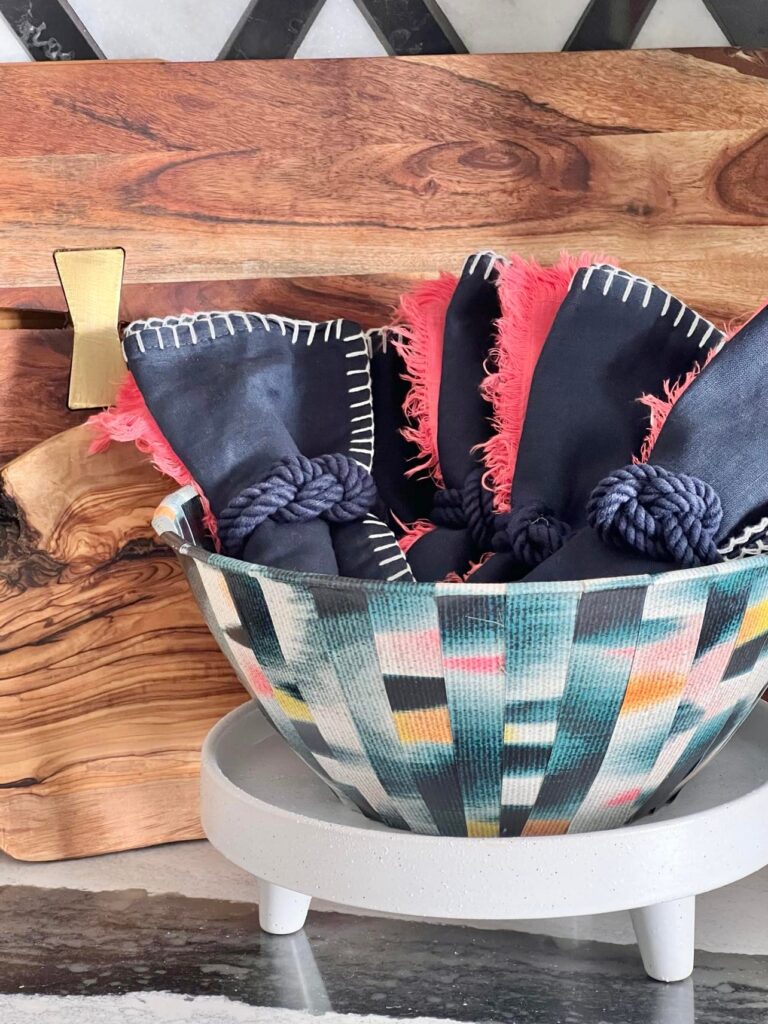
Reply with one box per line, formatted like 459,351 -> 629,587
399,252 -> 501,581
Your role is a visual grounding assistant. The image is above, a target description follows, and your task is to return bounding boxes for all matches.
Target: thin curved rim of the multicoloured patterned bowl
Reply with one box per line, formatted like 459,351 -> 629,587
153,487 -> 768,597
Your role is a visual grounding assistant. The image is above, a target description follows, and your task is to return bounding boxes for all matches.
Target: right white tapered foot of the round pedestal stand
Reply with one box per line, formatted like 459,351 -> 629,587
630,896 -> 696,981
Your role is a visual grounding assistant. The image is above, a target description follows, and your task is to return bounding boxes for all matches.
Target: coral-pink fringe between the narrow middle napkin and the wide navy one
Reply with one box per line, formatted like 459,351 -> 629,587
480,253 -> 607,512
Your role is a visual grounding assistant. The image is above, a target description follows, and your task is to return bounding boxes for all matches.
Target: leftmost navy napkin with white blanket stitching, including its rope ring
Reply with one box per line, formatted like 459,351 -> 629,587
118,311 -> 412,580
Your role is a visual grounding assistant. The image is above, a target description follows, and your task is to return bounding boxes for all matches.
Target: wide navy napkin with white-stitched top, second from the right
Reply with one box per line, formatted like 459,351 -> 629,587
472,263 -> 723,583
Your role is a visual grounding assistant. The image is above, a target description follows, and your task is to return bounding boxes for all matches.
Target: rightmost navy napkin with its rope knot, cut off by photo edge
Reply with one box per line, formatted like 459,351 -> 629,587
527,299 -> 768,580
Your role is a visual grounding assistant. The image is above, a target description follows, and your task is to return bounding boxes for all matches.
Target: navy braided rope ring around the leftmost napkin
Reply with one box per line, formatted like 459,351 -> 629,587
218,455 -> 377,558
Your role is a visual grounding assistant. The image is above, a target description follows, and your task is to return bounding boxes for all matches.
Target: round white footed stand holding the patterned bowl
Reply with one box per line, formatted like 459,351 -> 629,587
202,703 -> 768,981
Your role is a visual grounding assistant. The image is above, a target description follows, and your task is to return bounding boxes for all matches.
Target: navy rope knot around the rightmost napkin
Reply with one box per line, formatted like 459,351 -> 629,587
587,463 -> 723,568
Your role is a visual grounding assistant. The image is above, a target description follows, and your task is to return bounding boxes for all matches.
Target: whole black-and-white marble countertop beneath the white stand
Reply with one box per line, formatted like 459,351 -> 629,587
0,843 -> 768,1024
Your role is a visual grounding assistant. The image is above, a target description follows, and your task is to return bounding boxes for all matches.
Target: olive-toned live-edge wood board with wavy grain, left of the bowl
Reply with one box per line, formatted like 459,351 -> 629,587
0,426 -> 246,860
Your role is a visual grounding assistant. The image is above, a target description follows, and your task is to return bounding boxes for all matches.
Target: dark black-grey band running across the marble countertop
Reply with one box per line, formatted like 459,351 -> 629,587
0,886 -> 768,1024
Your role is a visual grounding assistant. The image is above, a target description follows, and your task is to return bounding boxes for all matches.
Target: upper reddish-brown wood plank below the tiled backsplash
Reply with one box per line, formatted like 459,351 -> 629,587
0,50 -> 768,313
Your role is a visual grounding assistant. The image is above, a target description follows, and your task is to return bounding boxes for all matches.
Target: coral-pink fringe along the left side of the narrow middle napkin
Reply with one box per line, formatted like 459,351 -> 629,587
390,272 -> 458,483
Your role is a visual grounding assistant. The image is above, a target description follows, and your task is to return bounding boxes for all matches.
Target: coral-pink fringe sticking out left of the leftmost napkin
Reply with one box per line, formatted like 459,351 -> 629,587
88,374 -> 218,549
